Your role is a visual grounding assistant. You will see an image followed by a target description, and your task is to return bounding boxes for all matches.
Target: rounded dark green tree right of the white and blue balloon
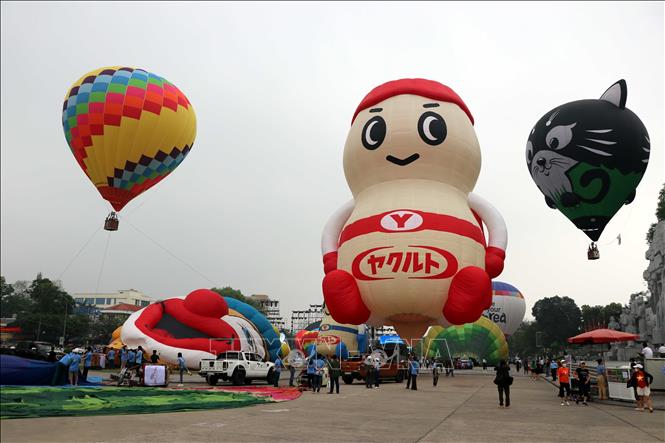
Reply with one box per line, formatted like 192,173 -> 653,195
531,295 -> 582,350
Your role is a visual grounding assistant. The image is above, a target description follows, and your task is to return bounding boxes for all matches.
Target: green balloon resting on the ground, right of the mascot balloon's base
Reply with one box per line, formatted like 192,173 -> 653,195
423,317 -> 508,365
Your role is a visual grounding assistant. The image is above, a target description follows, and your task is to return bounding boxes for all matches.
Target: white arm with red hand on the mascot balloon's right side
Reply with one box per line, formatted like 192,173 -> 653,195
469,193 -> 508,278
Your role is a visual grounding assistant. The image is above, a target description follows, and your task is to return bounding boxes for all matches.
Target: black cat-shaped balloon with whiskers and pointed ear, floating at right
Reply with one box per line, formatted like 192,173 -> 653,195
526,80 -> 650,241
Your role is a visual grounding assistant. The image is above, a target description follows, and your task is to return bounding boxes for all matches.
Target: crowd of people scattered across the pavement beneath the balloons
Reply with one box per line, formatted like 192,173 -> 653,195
47,342 -> 665,412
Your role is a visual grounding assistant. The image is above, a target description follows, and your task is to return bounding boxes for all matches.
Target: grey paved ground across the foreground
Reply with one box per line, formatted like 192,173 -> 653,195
0,370 -> 665,443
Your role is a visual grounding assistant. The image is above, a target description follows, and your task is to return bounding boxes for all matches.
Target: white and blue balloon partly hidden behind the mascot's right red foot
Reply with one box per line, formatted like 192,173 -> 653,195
483,281 -> 526,336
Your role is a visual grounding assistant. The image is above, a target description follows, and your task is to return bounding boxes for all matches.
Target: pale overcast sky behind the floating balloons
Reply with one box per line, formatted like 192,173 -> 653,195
1,2 -> 664,326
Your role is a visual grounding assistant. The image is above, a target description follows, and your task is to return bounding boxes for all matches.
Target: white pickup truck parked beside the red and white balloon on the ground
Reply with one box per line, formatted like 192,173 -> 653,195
199,351 -> 275,386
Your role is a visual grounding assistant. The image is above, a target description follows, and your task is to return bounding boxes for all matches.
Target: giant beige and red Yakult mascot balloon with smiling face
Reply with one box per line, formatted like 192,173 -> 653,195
321,79 -> 507,339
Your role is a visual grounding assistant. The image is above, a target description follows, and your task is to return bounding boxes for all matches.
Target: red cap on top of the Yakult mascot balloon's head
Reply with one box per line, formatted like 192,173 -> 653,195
351,78 -> 473,124
